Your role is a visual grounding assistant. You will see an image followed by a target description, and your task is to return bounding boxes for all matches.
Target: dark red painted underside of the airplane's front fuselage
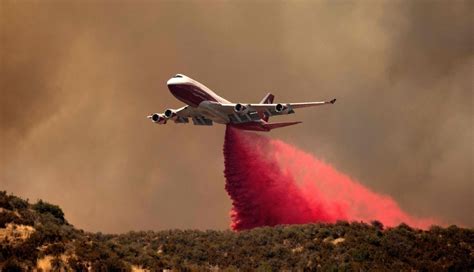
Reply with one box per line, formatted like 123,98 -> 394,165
168,84 -> 217,107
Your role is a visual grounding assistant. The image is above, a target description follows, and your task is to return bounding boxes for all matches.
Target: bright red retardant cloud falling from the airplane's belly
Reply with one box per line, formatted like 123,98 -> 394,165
224,127 -> 434,230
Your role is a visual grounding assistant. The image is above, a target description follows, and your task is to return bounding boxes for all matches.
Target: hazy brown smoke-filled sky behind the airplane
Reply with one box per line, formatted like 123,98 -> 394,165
0,1 -> 474,232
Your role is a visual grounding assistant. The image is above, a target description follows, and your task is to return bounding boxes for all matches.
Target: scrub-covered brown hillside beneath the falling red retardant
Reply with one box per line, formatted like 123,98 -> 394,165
0,192 -> 474,271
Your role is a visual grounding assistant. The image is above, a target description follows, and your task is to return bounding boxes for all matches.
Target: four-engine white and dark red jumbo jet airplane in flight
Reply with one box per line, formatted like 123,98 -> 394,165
147,74 -> 336,131
